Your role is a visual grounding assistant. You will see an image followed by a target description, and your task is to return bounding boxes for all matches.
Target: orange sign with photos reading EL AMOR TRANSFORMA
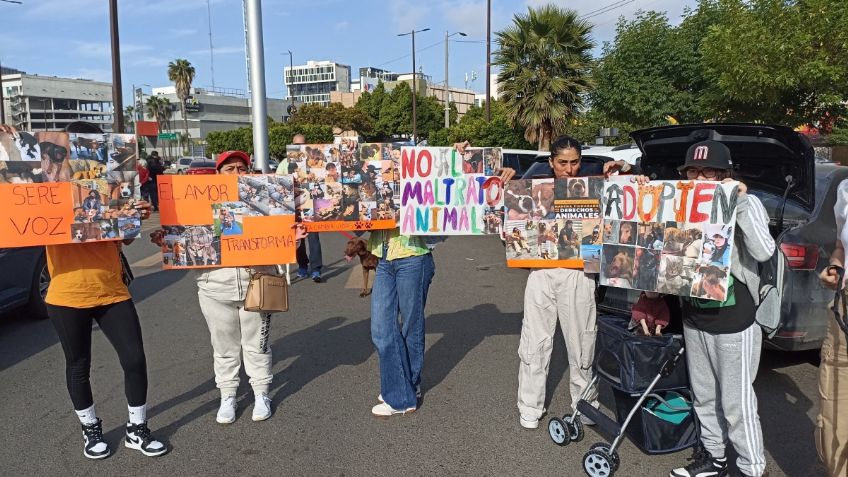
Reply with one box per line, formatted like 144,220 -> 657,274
157,174 -> 296,269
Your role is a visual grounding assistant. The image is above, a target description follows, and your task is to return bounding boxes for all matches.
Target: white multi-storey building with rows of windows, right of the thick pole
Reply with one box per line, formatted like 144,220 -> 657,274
283,60 -> 351,106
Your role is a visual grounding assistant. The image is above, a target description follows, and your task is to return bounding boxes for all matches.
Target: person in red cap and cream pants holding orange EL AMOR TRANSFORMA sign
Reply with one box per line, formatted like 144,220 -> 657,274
151,151 -> 307,424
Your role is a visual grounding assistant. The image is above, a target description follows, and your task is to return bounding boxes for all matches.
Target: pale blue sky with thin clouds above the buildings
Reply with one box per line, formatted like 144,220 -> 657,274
0,0 -> 697,104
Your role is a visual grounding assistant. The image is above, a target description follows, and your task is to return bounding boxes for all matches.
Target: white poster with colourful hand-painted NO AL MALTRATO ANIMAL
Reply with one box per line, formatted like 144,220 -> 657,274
400,147 -> 503,235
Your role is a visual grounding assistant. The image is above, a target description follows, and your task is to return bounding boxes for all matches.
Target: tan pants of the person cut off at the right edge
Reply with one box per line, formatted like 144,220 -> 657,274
816,318 -> 848,477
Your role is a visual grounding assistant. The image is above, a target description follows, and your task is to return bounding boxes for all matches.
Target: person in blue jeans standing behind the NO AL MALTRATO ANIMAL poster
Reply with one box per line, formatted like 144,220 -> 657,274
369,229 -> 436,417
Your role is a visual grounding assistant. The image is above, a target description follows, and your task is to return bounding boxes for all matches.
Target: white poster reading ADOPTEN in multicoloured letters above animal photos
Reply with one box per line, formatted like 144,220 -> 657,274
601,178 -> 738,301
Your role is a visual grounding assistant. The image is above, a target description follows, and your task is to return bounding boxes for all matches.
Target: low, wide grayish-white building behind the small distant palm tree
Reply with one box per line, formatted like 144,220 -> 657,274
142,86 -> 299,139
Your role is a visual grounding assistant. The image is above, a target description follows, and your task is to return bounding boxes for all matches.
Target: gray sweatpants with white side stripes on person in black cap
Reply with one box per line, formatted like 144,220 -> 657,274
683,322 -> 766,476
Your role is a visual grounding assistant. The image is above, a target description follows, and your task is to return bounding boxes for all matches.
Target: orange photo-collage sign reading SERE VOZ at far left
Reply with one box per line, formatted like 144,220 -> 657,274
0,132 -> 141,247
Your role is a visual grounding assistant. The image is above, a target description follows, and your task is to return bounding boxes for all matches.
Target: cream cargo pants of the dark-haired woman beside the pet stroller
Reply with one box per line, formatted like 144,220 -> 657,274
518,268 -> 598,419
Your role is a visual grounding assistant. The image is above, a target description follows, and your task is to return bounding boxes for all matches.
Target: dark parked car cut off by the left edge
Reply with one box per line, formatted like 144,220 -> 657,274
0,247 -> 50,319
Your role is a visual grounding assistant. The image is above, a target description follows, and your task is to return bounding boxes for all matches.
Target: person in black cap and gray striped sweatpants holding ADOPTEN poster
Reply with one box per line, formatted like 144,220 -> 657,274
637,140 -> 778,477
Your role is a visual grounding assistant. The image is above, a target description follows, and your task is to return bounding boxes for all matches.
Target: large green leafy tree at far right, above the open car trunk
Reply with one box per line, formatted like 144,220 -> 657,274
701,0 -> 848,126
